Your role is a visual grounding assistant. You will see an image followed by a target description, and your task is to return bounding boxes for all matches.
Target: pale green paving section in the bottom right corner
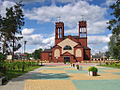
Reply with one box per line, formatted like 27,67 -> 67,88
72,79 -> 120,90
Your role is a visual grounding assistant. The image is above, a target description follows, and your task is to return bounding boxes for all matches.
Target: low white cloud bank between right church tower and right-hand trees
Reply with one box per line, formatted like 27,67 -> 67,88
88,34 -> 112,54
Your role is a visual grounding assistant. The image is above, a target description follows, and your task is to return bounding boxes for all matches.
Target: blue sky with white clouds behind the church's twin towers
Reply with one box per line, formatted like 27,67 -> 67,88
0,0 -> 115,54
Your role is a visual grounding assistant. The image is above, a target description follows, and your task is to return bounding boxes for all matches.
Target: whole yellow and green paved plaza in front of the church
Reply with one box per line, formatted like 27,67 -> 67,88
0,63 -> 120,90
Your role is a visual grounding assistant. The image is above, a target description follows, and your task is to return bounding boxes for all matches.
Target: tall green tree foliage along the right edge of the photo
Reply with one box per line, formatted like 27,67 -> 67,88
107,0 -> 120,59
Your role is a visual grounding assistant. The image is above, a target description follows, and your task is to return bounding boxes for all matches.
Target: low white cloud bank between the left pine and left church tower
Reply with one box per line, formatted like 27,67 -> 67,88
18,28 -> 54,53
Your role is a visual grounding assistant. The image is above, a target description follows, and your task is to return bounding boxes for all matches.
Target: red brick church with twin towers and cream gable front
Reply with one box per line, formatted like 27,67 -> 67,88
41,21 -> 91,62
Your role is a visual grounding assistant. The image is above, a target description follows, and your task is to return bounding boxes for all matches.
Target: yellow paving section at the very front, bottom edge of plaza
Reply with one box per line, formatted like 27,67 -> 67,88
24,80 -> 77,90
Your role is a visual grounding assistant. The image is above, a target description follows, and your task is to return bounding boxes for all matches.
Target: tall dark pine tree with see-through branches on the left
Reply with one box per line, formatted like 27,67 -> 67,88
1,2 -> 24,59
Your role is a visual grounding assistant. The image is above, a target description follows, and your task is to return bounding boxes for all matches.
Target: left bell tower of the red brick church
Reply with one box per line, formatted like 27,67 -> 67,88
55,22 -> 64,44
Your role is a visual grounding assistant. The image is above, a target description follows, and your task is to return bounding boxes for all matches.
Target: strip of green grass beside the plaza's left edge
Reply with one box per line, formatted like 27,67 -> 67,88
5,66 -> 41,80
